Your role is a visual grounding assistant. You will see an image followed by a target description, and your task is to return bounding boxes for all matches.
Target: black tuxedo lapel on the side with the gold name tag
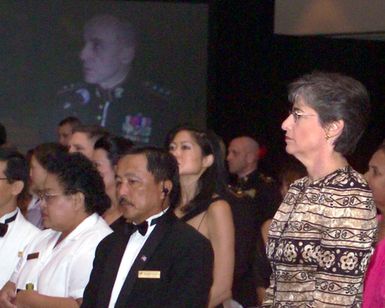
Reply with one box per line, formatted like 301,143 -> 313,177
116,210 -> 176,307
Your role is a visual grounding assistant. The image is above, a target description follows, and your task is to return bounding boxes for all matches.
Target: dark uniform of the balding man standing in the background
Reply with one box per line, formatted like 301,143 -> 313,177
229,170 -> 281,307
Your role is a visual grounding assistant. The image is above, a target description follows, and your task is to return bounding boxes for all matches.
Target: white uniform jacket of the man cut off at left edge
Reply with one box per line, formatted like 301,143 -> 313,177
0,208 -> 40,289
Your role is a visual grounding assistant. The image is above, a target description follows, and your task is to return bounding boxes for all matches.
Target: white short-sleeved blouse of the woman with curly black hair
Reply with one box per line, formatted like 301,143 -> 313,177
11,213 -> 112,299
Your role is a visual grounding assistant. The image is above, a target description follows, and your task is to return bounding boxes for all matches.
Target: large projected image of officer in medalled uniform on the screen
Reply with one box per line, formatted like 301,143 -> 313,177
57,15 -> 173,144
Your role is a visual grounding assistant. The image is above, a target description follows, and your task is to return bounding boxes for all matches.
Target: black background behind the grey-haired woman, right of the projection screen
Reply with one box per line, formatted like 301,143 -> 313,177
208,1 -> 385,174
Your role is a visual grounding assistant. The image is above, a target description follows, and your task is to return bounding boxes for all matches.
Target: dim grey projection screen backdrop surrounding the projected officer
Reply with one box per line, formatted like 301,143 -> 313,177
0,0 -> 209,151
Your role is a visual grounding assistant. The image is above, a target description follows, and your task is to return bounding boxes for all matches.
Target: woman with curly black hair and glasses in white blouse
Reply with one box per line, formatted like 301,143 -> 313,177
0,154 -> 112,307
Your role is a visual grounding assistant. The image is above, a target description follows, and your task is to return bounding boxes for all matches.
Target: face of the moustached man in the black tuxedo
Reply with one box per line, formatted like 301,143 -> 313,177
116,154 -> 165,223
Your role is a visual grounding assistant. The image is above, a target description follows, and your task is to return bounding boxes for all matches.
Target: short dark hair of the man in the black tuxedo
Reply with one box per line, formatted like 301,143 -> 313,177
124,146 -> 180,209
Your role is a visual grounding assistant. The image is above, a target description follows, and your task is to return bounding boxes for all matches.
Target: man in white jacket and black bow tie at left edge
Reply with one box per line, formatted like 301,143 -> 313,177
0,149 -> 39,288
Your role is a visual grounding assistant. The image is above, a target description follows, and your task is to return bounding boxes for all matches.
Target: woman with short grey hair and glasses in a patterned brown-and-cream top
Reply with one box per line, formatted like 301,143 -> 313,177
264,72 -> 376,307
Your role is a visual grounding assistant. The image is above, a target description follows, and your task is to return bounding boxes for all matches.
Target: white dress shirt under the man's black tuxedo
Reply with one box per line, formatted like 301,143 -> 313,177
108,210 -> 167,308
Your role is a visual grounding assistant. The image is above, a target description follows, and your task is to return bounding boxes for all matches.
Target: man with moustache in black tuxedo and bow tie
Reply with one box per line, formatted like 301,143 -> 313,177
82,147 -> 213,308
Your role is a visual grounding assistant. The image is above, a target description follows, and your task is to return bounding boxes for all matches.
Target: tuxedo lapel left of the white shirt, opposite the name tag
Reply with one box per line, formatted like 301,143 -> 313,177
95,234 -> 130,307
